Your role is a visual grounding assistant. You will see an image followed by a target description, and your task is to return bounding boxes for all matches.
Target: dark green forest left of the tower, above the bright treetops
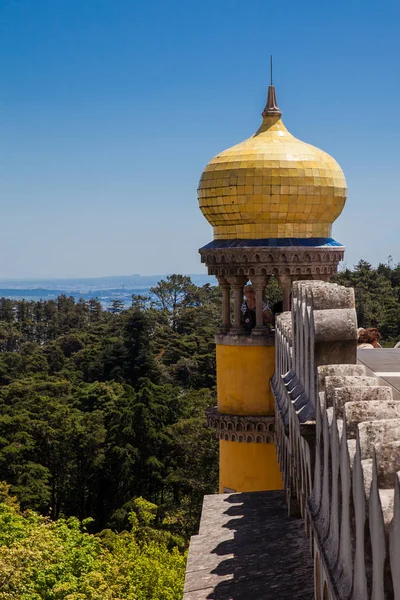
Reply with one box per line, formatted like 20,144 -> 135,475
0,275 -> 220,539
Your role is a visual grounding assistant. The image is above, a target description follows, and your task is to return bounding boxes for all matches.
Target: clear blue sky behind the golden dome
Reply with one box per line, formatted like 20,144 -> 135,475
0,0 -> 400,278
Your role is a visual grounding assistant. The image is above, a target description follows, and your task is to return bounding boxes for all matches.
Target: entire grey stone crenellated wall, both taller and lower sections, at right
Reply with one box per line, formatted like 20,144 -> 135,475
272,282 -> 400,600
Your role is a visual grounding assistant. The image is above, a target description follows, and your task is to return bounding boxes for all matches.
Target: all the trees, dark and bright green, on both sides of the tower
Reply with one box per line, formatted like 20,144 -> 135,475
0,261 -> 400,600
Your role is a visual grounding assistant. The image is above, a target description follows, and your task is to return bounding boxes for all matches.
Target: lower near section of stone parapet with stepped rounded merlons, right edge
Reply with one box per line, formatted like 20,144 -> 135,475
308,365 -> 400,600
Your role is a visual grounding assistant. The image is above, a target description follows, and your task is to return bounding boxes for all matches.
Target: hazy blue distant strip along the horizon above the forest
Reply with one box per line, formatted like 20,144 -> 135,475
0,274 -> 217,306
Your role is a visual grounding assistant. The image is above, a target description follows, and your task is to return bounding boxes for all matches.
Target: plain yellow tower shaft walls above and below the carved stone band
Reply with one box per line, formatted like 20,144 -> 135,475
216,336 -> 282,493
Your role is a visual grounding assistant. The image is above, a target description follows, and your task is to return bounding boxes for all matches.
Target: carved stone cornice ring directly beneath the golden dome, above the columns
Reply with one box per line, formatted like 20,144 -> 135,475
199,246 -> 344,279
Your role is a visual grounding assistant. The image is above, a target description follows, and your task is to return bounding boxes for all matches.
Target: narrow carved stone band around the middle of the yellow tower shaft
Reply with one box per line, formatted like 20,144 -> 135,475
206,406 -> 275,444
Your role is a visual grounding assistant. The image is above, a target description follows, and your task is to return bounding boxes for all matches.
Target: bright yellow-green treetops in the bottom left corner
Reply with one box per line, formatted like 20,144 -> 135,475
0,484 -> 185,600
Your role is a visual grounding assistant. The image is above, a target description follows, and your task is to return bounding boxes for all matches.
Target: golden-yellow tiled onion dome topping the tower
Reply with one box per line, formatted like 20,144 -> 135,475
198,85 -> 347,240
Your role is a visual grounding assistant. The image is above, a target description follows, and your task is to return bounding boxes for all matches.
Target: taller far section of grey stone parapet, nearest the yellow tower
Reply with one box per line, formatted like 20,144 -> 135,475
271,281 -> 357,518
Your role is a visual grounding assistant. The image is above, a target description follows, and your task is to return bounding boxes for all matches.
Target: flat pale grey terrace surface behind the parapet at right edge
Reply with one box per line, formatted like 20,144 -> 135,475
357,348 -> 400,400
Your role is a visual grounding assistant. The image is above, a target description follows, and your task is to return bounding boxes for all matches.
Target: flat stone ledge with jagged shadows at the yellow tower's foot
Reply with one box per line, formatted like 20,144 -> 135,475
183,492 -> 314,600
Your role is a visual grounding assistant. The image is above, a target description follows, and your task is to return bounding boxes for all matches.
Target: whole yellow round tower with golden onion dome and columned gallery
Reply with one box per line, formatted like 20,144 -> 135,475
198,77 -> 347,493
